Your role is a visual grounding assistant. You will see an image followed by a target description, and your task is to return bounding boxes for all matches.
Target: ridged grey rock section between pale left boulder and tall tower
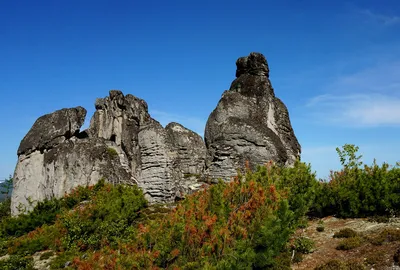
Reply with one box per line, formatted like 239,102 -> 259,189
89,90 -> 206,202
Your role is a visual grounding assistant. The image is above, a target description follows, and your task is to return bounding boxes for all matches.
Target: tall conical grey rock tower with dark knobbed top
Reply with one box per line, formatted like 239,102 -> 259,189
205,53 -> 300,180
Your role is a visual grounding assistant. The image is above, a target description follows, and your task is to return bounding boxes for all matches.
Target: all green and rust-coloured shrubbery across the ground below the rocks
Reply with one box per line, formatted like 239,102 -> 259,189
0,145 -> 400,269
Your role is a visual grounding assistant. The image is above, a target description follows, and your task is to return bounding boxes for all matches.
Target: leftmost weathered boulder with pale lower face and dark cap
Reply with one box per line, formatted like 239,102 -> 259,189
11,107 -> 132,215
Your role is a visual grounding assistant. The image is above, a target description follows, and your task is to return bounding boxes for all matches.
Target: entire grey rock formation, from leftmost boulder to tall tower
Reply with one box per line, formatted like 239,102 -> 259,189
11,53 -> 300,215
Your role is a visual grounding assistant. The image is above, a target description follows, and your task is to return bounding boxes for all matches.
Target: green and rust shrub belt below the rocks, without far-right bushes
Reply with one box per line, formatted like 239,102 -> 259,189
2,162 -> 317,269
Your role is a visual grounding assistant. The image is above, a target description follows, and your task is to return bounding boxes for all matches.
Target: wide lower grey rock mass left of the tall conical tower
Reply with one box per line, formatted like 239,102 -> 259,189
12,90 -> 206,215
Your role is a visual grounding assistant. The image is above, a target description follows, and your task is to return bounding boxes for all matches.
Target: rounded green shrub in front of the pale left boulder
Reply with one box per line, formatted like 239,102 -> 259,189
60,184 -> 147,250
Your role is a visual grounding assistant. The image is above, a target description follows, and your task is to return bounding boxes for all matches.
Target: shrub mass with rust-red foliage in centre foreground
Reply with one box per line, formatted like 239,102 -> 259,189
70,168 -> 312,269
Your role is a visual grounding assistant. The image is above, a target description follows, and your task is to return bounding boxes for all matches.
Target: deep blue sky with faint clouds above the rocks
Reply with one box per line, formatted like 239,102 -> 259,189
0,0 -> 400,179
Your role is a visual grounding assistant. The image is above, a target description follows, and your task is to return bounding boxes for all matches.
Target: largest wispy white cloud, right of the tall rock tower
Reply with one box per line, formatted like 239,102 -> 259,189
306,57 -> 400,127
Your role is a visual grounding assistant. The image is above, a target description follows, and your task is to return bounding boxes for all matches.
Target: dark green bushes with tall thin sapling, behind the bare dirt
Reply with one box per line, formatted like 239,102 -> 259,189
310,145 -> 400,218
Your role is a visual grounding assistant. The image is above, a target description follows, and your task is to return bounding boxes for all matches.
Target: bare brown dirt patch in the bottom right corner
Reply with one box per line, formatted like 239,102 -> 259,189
292,217 -> 400,270
